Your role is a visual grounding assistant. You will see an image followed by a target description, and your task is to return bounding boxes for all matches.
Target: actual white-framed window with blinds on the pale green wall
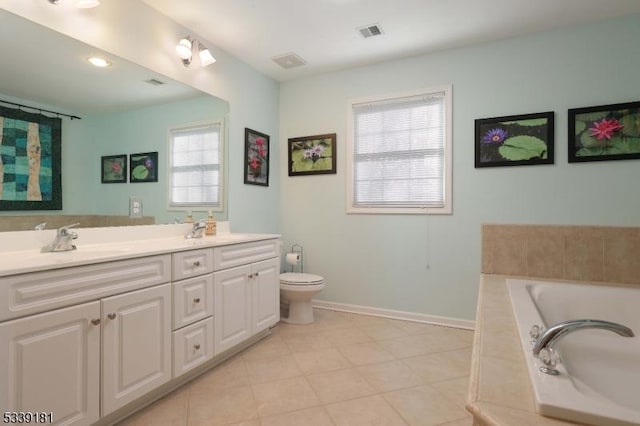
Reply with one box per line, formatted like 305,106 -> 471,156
347,86 -> 451,214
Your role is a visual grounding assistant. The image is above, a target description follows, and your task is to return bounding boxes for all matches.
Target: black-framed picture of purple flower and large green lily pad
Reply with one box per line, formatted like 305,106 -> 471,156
475,111 -> 554,167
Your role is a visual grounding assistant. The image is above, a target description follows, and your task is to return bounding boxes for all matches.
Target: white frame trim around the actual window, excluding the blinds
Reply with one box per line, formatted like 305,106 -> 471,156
345,85 -> 453,214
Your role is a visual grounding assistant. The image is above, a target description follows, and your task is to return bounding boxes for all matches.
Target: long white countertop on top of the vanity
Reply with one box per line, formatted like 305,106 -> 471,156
0,225 -> 280,277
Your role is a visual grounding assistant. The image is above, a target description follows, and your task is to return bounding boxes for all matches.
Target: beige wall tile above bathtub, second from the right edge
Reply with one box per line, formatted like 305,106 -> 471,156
564,236 -> 604,281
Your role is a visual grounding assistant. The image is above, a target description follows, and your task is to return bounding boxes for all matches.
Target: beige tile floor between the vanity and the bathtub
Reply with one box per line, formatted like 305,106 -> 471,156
120,309 -> 473,426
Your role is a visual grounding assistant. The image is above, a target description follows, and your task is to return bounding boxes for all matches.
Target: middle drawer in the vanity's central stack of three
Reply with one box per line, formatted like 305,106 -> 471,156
173,274 -> 213,330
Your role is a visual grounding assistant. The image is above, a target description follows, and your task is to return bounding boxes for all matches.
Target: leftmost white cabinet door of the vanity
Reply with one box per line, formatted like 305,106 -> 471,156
0,302 -> 100,425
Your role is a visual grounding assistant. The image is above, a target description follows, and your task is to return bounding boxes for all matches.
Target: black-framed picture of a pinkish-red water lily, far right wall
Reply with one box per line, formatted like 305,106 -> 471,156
569,102 -> 640,163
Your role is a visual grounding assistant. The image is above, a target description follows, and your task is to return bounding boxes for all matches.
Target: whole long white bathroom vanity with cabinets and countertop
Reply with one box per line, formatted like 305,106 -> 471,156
0,225 -> 281,425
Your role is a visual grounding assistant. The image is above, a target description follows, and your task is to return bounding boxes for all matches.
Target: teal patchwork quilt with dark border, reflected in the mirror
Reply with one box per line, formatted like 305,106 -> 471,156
0,107 -> 62,210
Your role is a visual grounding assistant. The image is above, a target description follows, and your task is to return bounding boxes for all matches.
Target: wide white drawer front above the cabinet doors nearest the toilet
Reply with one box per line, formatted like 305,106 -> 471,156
213,239 -> 280,271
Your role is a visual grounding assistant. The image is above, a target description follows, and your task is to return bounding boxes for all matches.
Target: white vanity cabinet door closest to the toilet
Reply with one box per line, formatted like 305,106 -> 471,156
251,258 -> 280,334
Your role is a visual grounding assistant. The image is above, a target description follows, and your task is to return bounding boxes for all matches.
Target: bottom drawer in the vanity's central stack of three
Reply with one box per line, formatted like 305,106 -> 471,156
173,317 -> 213,378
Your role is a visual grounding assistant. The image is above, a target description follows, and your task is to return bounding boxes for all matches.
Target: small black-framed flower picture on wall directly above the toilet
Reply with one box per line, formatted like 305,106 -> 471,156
289,133 -> 336,176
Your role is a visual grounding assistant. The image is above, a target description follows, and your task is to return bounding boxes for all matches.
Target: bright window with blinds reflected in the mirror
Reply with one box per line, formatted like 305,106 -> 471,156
169,123 -> 224,211
